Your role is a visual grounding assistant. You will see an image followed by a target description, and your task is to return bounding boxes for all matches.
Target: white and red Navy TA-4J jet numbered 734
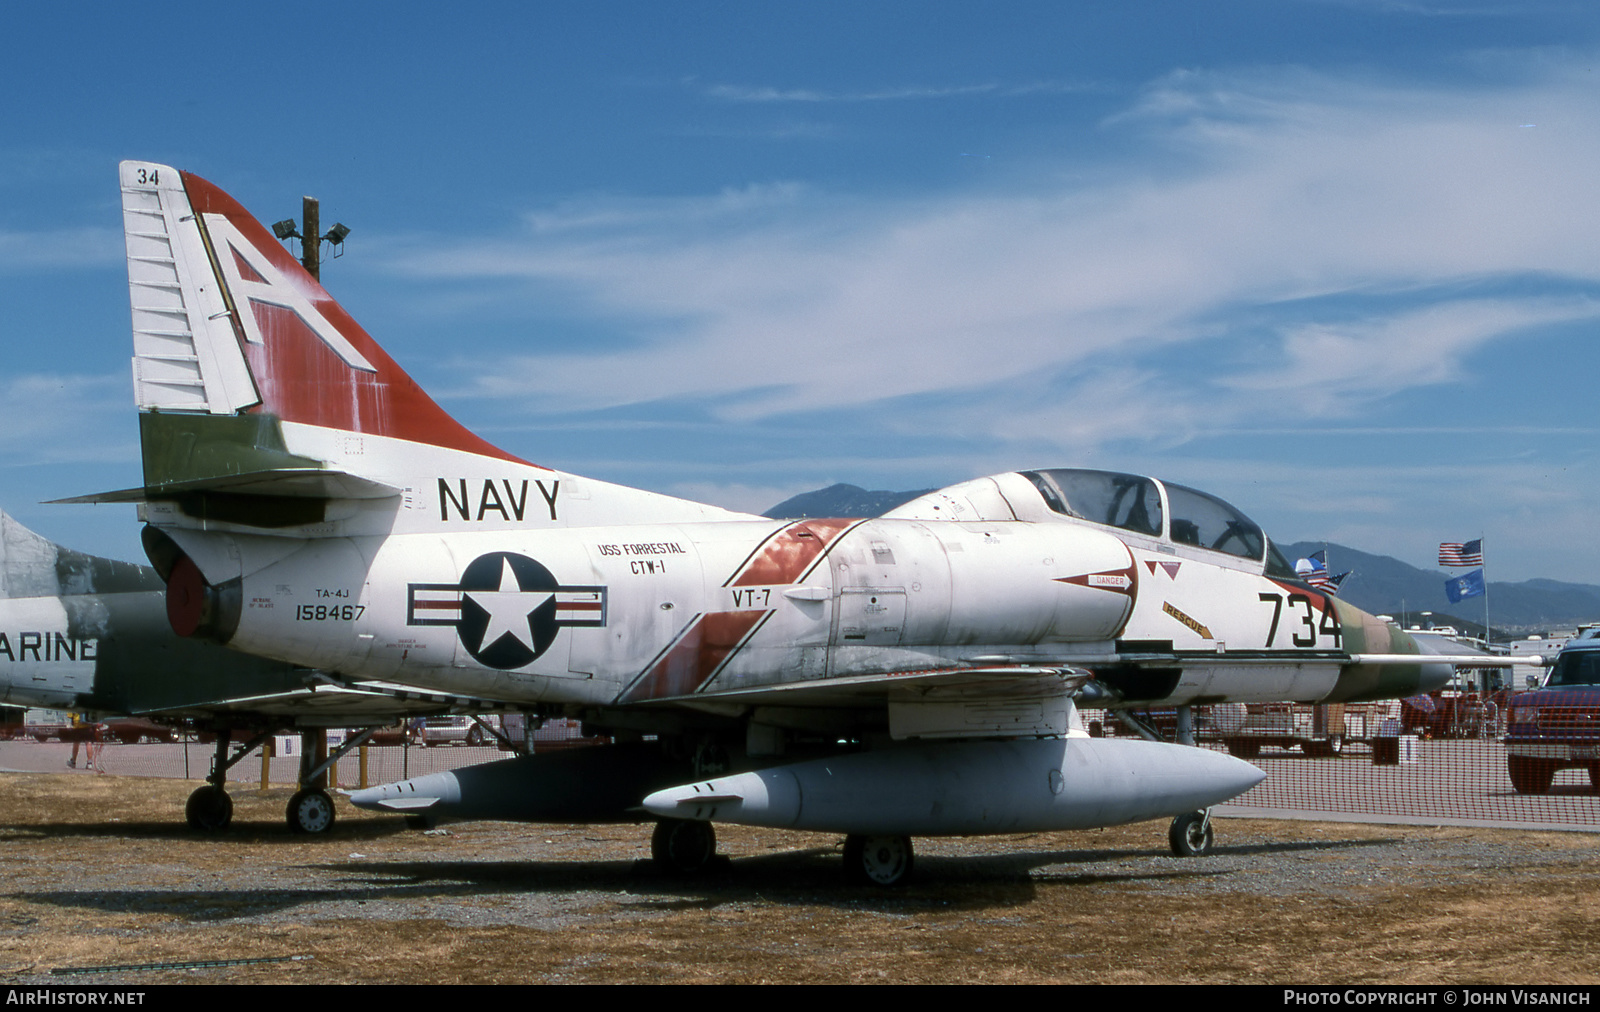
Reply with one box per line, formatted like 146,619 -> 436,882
90,162 -> 1484,882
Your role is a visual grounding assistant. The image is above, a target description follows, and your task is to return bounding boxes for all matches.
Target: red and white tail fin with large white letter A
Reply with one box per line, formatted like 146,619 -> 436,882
120,162 -> 525,496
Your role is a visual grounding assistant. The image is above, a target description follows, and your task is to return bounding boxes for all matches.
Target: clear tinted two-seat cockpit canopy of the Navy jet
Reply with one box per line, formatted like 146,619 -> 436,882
1021,468 -> 1294,580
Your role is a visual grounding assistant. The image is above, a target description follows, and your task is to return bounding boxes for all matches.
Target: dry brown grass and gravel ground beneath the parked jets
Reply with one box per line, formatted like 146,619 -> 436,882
0,773 -> 1600,986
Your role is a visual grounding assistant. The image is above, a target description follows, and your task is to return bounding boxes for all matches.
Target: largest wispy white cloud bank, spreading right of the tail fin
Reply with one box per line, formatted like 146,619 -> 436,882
380,53 -> 1600,473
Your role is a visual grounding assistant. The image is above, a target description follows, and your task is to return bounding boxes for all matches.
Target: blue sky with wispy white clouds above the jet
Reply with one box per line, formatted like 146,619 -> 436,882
0,0 -> 1600,581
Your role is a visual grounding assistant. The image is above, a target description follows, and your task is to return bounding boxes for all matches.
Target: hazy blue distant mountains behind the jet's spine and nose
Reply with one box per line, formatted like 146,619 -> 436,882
762,484 -> 1600,633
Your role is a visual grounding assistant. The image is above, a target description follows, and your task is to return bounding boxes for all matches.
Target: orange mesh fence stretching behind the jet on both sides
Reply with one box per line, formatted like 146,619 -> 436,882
9,698 -> 1600,829
